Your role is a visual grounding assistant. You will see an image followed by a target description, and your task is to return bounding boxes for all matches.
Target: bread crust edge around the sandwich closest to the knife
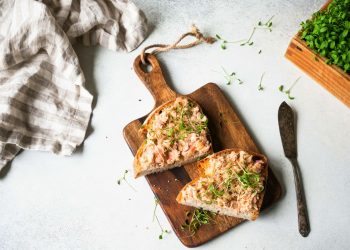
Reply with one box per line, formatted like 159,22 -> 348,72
176,148 -> 268,220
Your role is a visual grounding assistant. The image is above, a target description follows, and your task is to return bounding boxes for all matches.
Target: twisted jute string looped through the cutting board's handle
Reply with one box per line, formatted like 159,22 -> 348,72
141,25 -> 216,64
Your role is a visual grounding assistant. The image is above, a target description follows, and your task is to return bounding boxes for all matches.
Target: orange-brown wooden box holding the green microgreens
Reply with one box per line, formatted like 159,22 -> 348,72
285,1 -> 350,108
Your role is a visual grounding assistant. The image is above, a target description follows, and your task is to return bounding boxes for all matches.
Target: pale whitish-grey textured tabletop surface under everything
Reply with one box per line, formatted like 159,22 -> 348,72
0,0 -> 350,250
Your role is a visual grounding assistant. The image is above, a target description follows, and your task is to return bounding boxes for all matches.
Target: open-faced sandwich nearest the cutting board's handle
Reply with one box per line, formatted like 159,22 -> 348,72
134,97 -> 212,177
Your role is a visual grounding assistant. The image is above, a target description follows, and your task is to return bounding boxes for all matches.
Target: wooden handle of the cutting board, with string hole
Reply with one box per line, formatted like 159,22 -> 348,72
134,54 -> 177,106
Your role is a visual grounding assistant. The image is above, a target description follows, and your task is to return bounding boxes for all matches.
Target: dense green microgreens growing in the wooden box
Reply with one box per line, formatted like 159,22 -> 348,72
300,0 -> 350,73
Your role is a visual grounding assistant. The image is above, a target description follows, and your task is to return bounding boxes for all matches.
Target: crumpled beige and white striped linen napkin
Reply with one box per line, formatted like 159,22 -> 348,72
0,0 -> 147,169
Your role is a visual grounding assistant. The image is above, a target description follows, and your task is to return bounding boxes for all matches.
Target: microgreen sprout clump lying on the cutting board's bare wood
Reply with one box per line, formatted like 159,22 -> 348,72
181,208 -> 215,236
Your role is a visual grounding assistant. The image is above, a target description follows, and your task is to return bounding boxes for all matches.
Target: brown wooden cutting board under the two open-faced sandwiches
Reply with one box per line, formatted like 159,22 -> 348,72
123,55 -> 281,247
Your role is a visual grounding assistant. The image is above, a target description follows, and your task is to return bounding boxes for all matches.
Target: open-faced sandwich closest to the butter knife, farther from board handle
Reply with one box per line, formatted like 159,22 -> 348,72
176,149 -> 268,220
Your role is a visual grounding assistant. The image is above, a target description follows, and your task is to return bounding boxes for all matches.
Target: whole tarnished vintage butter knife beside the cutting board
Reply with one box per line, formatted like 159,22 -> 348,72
278,102 -> 310,237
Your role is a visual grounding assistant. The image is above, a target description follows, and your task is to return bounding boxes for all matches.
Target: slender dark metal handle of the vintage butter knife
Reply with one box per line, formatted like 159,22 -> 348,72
290,158 -> 310,237
